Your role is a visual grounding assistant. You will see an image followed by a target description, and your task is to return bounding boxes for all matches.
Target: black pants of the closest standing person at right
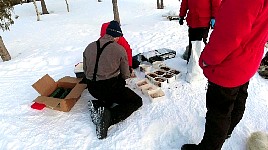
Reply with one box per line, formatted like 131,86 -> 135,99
199,82 -> 249,150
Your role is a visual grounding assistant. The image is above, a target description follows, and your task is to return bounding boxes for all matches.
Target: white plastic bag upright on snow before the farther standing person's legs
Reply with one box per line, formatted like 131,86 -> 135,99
186,41 -> 205,83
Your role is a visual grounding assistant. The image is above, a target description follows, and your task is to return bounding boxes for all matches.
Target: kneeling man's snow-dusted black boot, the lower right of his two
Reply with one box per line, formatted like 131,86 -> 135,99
96,107 -> 111,139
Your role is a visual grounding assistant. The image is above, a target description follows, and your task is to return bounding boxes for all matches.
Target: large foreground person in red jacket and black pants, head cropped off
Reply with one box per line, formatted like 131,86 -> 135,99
181,0 -> 268,150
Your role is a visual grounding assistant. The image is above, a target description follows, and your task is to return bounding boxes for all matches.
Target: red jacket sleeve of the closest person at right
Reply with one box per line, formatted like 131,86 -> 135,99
200,0 -> 261,65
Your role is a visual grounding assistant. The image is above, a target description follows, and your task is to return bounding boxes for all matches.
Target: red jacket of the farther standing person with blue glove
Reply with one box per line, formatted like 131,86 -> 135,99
179,0 -> 221,28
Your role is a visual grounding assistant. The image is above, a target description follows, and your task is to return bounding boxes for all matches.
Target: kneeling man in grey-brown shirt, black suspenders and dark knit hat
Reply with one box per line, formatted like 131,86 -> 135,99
83,21 -> 142,139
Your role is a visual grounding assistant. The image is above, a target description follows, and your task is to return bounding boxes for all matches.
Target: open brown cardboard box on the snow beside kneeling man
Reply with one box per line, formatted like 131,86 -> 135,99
32,74 -> 87,112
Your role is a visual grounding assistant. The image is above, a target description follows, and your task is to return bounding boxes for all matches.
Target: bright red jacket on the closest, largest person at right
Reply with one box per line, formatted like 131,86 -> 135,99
199,0 -> 268,87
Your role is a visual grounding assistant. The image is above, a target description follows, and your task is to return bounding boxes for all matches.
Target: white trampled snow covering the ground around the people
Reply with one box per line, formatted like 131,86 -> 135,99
0,0 -> 268,150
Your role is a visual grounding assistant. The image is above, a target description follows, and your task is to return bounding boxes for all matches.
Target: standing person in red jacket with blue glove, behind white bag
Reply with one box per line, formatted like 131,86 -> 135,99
179,0 -> 221,63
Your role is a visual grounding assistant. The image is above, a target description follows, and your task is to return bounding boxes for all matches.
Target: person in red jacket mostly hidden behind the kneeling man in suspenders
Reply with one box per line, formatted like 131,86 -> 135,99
100,22 -> 139,76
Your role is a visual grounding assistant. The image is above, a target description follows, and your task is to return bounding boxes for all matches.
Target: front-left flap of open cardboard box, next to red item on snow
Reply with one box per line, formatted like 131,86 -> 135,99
34,96 -> 63,109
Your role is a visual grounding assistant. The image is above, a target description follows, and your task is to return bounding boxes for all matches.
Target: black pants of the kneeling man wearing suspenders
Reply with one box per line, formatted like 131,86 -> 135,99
88,78 -> 142,125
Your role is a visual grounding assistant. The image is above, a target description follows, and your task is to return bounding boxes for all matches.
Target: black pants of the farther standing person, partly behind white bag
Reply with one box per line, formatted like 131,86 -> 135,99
187,27 -> 209,62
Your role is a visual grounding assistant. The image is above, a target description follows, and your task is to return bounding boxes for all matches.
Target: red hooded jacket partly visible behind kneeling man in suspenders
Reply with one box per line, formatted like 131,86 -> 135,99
100,22 -> 132,67
